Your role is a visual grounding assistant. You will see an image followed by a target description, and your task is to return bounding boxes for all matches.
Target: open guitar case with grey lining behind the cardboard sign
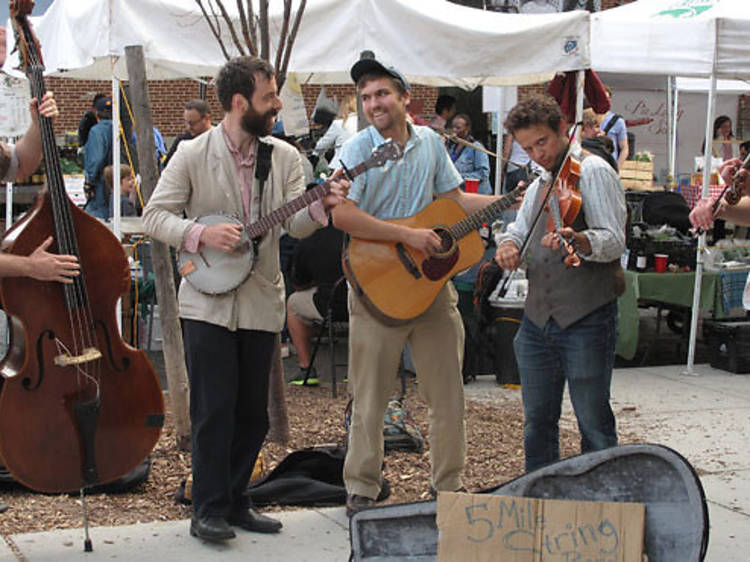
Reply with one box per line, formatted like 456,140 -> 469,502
349,444 -> 708,562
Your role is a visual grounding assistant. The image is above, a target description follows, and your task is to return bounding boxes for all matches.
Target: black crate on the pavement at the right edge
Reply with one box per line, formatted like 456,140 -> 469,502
703,318 -> 750,375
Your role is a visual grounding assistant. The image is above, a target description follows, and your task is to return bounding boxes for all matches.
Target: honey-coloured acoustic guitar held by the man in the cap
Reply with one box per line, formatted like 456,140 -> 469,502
343,188 -> 523,324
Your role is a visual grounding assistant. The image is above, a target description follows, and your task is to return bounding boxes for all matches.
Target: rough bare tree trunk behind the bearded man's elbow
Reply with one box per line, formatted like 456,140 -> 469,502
125,45 -> 190,450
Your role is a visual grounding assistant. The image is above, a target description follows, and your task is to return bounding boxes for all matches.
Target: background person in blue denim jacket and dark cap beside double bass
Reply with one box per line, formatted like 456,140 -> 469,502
83,96 -> 112,219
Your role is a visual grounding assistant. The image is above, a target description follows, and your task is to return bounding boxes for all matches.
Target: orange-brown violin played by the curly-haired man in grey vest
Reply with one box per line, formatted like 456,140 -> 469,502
545,151 -> 583,267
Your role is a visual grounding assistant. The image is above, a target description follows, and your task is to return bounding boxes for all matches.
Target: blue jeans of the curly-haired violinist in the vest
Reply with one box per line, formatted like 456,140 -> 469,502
513,300 -> 617,472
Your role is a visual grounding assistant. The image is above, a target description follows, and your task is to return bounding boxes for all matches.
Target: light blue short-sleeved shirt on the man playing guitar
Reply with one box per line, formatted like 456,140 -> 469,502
341,123 -> 463,220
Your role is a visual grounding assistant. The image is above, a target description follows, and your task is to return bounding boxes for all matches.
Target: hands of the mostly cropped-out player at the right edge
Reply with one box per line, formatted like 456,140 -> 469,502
690,158 -> 750,230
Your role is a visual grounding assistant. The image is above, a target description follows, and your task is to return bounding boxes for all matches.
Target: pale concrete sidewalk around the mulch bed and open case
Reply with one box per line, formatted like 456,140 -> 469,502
0,365 -> 750,562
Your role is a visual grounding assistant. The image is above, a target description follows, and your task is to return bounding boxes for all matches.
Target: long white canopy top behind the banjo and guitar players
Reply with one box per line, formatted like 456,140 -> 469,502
4,0 -> 589,88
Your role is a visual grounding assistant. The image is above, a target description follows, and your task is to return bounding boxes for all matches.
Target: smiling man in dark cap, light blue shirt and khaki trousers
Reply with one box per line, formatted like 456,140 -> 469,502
332,59 -> 506,516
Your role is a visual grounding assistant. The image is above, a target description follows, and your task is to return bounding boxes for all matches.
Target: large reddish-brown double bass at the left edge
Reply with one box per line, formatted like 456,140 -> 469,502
0,0 -> 164,493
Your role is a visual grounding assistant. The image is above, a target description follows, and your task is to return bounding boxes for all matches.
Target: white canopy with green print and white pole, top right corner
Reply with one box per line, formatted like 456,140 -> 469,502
591,0 -> 750,374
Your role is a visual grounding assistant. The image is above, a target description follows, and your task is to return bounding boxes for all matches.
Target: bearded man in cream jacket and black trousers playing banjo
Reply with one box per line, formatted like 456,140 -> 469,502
143,57 -> 349,541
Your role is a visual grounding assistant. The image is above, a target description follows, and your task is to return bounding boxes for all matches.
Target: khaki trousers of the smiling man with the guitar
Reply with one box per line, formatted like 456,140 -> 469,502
344,283 -> 466,498
